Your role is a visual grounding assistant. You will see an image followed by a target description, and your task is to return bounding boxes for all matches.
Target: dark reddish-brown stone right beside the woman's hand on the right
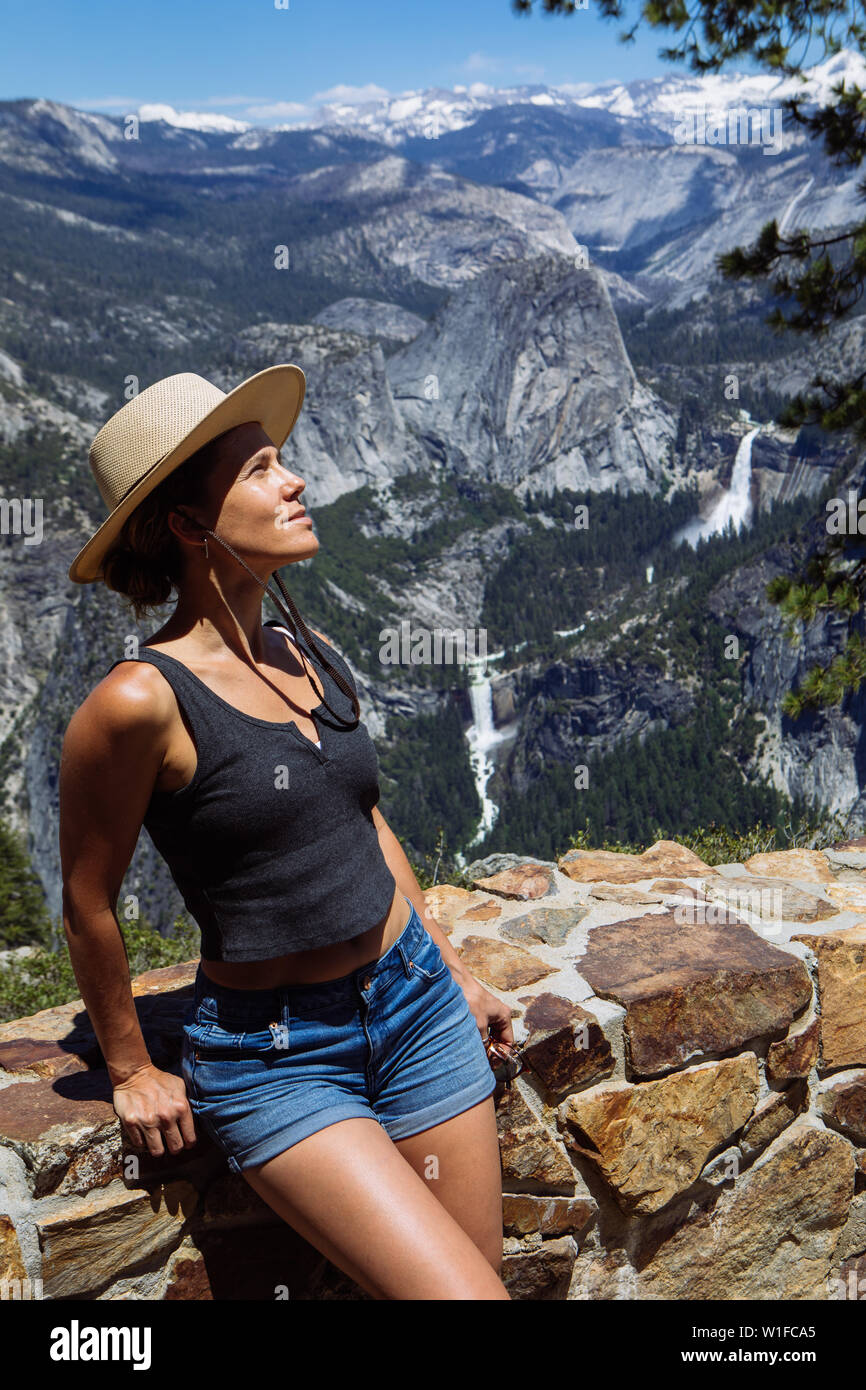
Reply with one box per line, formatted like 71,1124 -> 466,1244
523,994 -> 616,1104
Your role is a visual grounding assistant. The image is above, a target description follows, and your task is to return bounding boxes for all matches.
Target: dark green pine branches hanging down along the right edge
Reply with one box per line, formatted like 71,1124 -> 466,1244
512,0 -> 866,717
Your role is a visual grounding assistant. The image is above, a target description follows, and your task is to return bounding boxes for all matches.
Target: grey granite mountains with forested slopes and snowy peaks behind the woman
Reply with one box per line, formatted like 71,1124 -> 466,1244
0,53 -> 866,924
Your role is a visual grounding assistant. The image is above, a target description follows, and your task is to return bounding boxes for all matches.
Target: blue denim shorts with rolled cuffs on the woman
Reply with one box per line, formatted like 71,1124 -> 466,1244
181,898 -> 496,1173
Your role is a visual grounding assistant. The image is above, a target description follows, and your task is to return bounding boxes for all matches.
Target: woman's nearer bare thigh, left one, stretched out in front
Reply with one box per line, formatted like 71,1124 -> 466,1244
243,1106 -> 509,1300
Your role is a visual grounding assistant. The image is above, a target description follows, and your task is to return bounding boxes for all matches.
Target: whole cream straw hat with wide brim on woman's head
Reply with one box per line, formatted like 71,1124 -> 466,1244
70,363 -> 307,584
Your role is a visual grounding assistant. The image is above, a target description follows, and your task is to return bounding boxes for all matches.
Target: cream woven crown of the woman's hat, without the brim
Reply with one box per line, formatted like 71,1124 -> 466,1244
90,371 -> 225,512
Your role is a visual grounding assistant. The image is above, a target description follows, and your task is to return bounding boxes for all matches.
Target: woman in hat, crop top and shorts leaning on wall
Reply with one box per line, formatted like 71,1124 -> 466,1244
60,366 -> 513,1298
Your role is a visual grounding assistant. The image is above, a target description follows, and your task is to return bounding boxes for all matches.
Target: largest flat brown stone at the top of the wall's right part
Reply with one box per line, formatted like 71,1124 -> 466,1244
575,909 -> 812,1076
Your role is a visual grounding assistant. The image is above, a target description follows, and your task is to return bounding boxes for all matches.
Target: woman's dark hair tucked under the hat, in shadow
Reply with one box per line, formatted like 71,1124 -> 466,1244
103,436 -> 221,621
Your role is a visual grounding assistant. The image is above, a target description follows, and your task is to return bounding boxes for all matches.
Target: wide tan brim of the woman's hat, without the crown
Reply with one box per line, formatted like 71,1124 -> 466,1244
70,363 -> 306,584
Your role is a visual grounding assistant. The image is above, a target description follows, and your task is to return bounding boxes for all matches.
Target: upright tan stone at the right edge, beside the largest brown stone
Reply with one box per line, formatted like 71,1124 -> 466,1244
792,923 -> 866,1070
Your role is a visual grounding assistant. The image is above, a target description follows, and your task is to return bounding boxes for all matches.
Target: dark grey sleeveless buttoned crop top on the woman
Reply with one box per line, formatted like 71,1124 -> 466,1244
108,620 -> 396,960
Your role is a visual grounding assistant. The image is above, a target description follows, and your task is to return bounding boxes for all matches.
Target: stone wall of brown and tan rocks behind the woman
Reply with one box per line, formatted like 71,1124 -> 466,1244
0,837 -> 866,1301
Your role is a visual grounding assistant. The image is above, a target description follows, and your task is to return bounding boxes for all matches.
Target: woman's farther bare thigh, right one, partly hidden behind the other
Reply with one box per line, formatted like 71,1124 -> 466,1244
395,1095 -> 502,1275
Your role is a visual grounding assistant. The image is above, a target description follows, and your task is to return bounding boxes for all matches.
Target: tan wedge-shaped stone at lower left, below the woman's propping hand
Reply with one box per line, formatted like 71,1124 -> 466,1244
36,1182 -> 197,1298
